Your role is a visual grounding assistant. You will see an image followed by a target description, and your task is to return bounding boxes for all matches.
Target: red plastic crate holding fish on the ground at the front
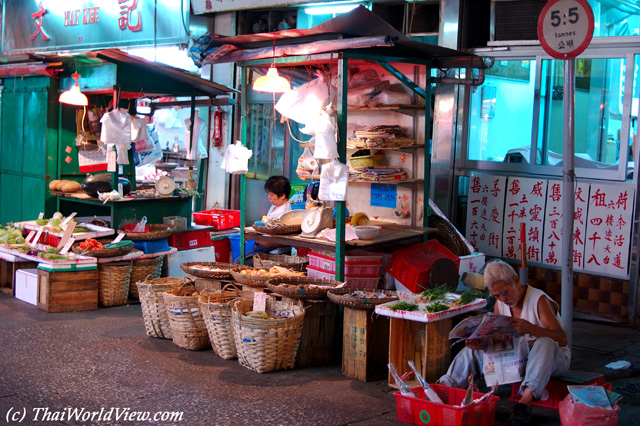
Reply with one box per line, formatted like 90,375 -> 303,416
393,384 -> 500,426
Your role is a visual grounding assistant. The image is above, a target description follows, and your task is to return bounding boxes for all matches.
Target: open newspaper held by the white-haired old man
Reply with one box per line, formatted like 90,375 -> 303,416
449,312 -> 529,386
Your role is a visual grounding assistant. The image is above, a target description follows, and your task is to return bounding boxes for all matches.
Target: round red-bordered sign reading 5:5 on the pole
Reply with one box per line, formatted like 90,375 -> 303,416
538,0 -> 593,59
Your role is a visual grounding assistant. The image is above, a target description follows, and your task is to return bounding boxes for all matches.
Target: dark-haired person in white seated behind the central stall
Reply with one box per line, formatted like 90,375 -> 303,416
235,176 -> 291,265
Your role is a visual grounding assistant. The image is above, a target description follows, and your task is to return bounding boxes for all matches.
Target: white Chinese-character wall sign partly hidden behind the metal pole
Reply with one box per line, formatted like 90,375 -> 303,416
542,180 -> 589,269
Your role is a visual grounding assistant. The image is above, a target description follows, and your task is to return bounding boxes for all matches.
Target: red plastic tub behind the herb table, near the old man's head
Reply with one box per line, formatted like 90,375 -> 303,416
387,240 -> 460,293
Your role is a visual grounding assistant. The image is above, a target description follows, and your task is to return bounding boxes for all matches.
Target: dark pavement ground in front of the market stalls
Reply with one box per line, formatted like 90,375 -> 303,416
0,293 -> 640,426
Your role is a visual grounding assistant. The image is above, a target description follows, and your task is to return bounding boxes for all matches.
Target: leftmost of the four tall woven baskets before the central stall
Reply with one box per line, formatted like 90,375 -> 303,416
137,275 -> 183,339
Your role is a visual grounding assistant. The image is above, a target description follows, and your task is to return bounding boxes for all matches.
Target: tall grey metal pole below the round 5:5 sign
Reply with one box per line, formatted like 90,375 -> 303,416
561,58 -> 576,348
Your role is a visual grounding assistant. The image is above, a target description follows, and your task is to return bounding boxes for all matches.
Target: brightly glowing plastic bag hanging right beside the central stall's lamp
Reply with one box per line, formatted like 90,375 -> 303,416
276,71 -> 336,124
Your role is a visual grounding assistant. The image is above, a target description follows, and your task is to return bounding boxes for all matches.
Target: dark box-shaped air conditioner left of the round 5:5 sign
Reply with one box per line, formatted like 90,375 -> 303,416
490,0 -> 547,42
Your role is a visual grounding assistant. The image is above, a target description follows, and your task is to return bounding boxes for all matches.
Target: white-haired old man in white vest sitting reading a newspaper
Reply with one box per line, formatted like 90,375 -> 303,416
437,260 -> 571,426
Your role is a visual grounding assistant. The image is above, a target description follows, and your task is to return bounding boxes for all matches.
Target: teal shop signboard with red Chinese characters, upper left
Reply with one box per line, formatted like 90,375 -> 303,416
2,0 -> 189,55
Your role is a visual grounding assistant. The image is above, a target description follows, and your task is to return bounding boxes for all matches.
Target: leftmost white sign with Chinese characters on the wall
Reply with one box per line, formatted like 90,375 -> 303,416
466,174 -> 507,256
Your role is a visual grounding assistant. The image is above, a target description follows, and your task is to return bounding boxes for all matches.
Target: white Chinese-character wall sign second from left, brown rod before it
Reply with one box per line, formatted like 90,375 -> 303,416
502,176 -> 547,262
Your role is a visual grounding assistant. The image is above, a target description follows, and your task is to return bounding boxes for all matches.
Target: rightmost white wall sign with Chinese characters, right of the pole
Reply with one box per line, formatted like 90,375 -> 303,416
584,183 -> 635,277
